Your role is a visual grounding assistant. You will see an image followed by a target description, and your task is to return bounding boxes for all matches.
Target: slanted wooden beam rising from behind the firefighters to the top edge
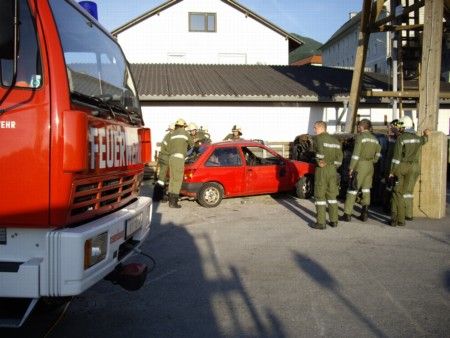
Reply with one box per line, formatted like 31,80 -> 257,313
345,0 -> 372,133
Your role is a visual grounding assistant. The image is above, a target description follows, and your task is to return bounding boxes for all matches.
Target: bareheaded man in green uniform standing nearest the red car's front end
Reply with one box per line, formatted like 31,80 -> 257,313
312,121 -> 343,230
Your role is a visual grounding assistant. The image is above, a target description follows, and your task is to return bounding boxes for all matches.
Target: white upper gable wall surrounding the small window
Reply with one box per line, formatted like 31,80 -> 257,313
118,0 -> 289,65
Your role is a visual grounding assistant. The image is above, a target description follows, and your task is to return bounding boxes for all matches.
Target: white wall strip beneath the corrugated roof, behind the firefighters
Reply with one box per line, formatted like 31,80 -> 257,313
142,105 -> 450,156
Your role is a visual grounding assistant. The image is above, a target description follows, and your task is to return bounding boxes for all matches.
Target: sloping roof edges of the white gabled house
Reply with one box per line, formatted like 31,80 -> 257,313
111,0 -> 303,52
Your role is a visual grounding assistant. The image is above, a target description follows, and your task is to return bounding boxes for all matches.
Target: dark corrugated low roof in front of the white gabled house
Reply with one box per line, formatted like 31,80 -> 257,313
131,64 -> 390,102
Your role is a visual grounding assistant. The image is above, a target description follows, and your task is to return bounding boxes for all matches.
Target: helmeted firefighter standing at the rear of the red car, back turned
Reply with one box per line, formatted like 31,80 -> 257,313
167,119 -> 194,208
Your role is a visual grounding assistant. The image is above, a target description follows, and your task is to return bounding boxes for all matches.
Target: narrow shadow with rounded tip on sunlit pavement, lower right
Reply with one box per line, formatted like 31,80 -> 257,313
293,251 -> 387,337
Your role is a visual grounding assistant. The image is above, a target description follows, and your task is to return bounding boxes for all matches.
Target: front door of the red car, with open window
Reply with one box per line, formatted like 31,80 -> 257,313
241,145 -> 289,195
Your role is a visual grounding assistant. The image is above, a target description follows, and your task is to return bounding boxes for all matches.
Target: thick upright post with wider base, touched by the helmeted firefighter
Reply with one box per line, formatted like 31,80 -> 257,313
414,0 -> 447,218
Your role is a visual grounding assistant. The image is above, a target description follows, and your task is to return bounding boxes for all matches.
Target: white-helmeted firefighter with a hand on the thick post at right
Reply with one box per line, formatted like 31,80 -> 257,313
389,116 -> 430,226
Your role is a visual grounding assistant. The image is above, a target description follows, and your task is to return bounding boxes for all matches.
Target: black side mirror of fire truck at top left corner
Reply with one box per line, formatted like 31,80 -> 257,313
0,0 -> 15,60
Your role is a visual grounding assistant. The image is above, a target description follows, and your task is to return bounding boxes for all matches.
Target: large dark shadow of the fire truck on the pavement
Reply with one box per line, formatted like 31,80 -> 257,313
47,186 -> 285,338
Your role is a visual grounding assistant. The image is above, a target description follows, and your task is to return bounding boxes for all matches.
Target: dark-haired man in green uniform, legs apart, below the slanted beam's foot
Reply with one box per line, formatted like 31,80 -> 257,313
342,119 -> 381,222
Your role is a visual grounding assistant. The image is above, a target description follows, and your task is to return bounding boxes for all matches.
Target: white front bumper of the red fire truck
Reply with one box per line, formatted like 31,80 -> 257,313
0,197 -> 152,298
